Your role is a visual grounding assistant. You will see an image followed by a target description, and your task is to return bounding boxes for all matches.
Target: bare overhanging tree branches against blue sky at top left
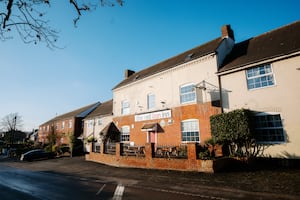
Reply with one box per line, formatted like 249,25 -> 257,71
0,0 -> 124,48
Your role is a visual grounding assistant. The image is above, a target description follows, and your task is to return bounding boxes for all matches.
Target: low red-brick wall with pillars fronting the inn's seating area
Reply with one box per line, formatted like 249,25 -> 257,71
86,143 -> 214,173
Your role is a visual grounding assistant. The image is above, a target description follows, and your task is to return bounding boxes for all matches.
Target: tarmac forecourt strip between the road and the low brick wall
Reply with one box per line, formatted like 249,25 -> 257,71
0,157 -> 300,199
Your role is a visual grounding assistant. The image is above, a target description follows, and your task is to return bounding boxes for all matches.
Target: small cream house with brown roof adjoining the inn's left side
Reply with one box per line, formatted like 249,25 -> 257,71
83,100 -> 119,152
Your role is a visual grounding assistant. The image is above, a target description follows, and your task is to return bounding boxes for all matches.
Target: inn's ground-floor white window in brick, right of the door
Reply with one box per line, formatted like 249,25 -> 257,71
181,119 -> 200,143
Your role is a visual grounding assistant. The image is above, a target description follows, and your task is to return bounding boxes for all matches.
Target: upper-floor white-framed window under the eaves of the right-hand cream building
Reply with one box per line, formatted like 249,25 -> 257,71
246,64 -> 275,90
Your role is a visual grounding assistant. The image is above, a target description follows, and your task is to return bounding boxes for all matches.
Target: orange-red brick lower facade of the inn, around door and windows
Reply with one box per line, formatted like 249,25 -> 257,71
113,103 -> 221,145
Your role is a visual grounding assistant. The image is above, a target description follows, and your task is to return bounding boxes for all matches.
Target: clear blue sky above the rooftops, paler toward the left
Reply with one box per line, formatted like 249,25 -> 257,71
0,0 -> 300,131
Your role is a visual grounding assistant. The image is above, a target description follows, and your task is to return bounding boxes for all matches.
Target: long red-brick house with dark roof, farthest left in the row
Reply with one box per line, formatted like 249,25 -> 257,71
38,102 -> 100,145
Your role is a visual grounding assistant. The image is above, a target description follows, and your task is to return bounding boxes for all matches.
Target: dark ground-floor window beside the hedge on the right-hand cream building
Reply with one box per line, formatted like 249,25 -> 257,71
254,112 -> 286,144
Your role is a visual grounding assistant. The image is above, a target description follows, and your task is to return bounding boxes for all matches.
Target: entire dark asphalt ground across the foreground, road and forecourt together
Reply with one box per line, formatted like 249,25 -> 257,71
0,157 -> 300,200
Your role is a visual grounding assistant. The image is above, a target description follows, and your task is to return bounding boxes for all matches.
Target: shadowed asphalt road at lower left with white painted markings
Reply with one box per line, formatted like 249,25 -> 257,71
0,165 -> 211,200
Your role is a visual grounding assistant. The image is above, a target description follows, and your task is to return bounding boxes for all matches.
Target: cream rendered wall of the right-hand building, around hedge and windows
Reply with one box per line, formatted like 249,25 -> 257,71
221,56 -> 300,158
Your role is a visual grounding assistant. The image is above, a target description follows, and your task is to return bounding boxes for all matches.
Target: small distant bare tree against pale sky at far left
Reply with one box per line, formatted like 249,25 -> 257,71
0,113 -> 23,132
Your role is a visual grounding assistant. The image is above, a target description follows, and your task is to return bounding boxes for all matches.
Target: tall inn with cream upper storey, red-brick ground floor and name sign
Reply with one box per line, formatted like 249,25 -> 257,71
113,25 -> 234,145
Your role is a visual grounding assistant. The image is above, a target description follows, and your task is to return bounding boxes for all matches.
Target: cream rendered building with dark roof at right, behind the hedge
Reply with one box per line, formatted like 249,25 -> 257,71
218,21 -> 300,158
